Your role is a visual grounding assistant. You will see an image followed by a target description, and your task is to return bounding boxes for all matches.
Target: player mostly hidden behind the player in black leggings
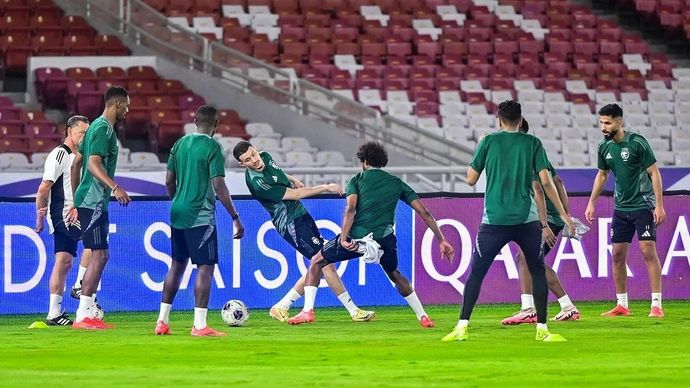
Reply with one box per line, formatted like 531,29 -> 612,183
501,117 -> 580,325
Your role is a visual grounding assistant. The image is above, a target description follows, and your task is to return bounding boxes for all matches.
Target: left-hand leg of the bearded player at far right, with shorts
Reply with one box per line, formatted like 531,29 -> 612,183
601,210 -> 635,317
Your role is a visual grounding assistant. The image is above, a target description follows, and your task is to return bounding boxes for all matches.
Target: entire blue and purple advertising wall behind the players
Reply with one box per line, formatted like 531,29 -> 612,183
0,195 -> 690,314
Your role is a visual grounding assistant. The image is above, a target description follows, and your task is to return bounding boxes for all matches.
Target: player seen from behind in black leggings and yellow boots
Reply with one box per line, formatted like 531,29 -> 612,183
442,100 -> 575,341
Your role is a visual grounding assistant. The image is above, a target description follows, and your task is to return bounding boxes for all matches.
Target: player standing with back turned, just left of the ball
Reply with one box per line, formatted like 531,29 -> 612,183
154,105 -> 244,337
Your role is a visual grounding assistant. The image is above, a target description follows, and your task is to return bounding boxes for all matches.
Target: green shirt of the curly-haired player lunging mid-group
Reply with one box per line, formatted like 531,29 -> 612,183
346,168 -> 419,239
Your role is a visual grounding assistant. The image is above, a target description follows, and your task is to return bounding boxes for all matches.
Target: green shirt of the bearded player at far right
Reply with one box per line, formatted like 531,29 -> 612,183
597,131 -> 656,211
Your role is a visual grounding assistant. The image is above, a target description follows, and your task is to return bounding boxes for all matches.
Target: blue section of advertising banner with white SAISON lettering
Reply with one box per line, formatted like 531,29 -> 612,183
0,199 -> 412,314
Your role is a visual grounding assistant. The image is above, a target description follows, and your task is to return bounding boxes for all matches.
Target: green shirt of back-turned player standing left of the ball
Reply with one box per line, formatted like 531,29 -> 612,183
168,133 -> 225,229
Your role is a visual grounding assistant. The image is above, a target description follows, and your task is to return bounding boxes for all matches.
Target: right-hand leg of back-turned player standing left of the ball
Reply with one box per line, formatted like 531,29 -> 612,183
189,225 -> 227,337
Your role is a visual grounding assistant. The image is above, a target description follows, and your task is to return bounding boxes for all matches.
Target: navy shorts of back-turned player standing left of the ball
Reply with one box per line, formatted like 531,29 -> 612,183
171,225 -> 218,265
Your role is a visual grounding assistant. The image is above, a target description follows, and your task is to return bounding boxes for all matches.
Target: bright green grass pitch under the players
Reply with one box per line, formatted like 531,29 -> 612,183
0,301 -> 690,387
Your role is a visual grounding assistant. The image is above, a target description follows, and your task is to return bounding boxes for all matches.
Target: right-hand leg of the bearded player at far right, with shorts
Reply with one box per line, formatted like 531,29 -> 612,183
633,210 -> 664,318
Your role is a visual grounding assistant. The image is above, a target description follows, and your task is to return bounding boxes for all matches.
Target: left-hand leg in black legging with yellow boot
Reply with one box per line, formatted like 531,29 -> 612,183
441,224 -> 511,341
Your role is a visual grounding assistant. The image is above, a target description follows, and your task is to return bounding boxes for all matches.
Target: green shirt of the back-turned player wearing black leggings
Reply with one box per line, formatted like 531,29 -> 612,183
470,131 -> 550,225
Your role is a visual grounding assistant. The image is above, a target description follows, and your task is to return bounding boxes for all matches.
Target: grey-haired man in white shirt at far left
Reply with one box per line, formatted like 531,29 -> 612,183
35,116 -> 89,326
